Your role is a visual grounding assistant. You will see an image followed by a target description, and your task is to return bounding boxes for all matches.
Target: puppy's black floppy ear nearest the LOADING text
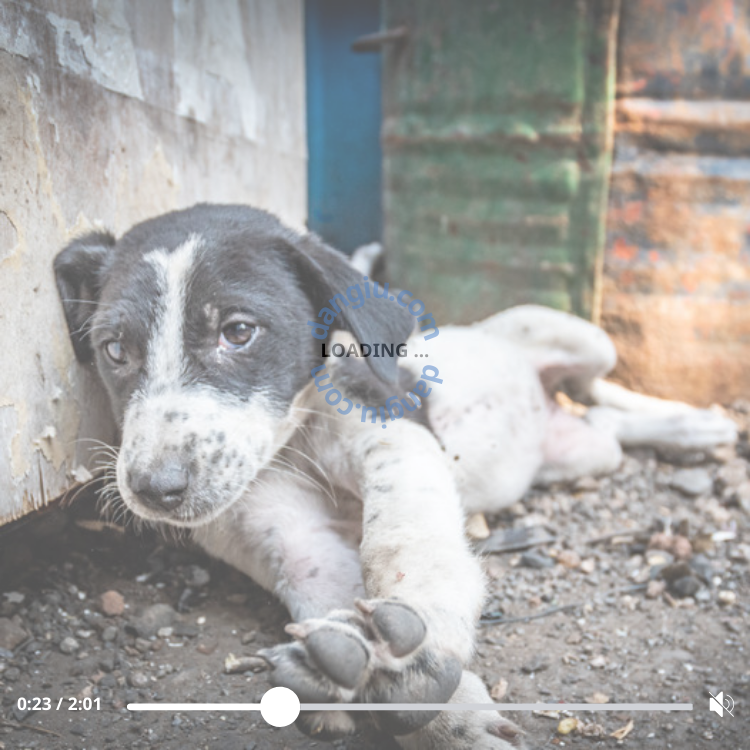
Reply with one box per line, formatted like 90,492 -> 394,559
294,234 -> 414,385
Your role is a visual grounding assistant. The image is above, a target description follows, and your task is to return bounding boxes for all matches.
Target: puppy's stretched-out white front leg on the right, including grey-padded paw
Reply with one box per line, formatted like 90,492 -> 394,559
268,422 -> 517,750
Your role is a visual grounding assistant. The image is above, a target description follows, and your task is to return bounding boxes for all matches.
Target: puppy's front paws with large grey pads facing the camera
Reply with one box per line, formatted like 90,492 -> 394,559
261,600 -> 468,737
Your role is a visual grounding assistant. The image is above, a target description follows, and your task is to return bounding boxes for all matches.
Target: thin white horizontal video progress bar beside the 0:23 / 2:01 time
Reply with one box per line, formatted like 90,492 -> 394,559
127,703 -> 693,711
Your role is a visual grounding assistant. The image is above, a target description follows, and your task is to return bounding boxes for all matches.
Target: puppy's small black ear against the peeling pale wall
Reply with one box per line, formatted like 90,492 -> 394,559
55,232 -> 115,364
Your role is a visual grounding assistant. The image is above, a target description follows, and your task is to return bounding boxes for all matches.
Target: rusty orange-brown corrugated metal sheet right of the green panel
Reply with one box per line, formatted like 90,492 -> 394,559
601,0 -> 750,404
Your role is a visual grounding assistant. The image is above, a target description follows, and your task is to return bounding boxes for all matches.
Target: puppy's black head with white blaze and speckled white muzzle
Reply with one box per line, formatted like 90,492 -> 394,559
55,205 -> 412,526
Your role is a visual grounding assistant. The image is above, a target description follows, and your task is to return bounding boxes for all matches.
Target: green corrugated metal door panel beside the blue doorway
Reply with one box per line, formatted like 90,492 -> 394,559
382,0 -> 618,322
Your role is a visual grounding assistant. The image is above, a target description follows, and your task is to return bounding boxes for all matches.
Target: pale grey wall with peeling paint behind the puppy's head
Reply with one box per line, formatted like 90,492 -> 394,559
0,0 -> 307,523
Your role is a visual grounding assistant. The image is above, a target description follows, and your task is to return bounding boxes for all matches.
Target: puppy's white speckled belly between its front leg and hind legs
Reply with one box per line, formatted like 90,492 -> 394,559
405,326 -> 549,512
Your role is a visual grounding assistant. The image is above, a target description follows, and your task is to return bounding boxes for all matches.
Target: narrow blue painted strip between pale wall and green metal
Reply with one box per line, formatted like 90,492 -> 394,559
305,0 -> 382,253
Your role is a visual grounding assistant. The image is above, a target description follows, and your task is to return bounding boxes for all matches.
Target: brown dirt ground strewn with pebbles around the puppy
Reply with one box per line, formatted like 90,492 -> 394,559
0,404 -> 750,750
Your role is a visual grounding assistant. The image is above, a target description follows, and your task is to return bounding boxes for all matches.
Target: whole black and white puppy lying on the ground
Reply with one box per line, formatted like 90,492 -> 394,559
55,205 -> 734,750
